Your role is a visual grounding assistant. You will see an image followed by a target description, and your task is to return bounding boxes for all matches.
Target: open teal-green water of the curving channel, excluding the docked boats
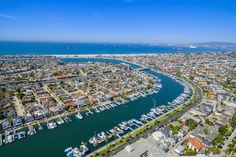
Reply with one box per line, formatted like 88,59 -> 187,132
0,58 -> 183,157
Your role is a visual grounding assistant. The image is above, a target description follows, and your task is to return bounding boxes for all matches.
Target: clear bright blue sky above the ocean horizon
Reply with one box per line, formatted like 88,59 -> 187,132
0,0 -> 236,43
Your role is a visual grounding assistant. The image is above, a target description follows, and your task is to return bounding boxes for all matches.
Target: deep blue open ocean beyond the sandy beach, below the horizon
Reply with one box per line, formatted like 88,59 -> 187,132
0,42 -> 225,55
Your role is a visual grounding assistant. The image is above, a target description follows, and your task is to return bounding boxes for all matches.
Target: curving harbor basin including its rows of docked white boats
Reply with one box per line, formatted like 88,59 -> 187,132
0,58 -> 188,157
